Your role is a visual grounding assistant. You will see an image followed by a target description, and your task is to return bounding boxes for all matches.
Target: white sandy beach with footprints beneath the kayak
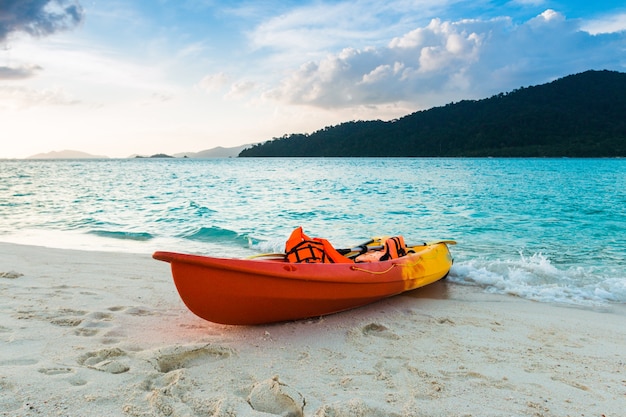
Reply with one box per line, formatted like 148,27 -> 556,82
0,243 -> 626,417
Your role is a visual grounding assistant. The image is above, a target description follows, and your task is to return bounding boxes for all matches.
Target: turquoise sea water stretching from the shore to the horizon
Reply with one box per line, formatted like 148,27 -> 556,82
0,158 -> 626,306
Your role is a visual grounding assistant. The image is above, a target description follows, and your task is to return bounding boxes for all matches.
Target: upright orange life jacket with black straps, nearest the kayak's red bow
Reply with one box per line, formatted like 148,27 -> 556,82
285,227 -> 353,263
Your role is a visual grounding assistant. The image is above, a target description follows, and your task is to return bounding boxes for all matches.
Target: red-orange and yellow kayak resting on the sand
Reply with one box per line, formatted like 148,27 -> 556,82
153,237 -> 454,325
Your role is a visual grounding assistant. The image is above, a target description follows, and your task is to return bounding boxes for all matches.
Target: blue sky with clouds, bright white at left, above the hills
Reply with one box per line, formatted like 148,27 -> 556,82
0,0 -> 626,158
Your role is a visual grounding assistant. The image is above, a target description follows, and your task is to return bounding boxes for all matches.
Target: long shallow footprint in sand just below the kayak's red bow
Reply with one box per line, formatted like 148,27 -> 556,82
151,345 -> 235,373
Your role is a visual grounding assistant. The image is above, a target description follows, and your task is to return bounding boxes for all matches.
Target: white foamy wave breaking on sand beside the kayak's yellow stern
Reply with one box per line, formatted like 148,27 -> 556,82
449,253 -> 626,306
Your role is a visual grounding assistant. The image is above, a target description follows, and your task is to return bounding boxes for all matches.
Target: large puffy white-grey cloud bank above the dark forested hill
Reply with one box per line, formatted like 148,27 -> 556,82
266,10 -> 626,107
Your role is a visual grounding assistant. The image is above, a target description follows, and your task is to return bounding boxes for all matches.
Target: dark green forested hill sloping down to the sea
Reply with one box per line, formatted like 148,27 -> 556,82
239,71 -> 626,157
